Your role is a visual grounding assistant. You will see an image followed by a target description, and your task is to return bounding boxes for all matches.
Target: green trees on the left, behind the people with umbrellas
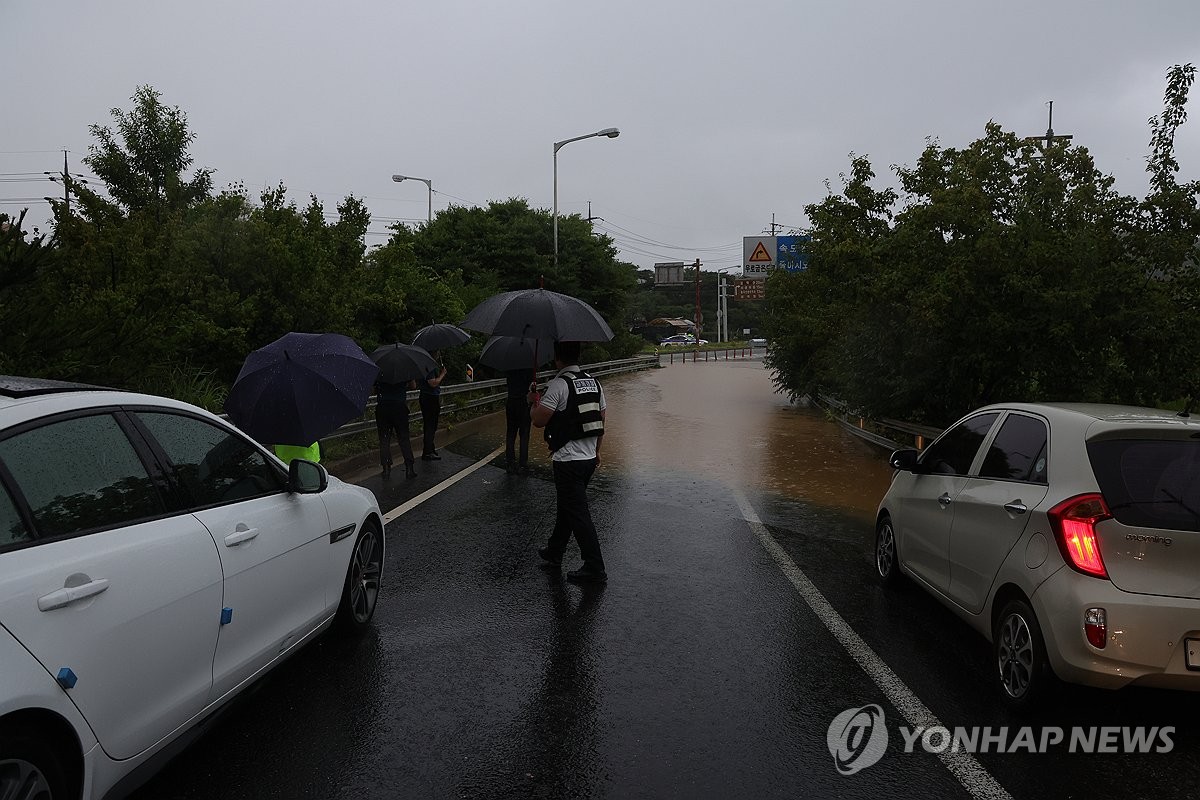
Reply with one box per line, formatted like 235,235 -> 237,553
0,86 -> 636,400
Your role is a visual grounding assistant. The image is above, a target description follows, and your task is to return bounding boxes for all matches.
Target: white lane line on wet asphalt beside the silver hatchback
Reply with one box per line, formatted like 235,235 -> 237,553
733,488 -> 1012,800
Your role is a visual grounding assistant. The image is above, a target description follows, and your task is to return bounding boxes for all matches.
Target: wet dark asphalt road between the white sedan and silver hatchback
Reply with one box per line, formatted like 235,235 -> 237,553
134,365 -> 1200,800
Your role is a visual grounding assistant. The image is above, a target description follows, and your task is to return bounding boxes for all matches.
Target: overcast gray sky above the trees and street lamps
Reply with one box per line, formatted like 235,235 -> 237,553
0,0 -> 1200,269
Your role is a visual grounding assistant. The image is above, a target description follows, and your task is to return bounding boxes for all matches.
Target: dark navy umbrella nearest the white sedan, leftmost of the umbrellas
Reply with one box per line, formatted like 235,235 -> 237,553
226,333 -> 379,447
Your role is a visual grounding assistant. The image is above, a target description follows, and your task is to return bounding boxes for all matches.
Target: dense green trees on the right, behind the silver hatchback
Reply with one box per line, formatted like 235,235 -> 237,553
768,67 -> 1200,425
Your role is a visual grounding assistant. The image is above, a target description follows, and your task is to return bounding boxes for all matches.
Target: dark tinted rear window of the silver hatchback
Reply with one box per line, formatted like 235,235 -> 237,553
1087,439 -> 1200,530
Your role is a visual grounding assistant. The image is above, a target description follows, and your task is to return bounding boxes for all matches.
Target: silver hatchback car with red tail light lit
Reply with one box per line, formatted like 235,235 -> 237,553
875,403 -> 1200,705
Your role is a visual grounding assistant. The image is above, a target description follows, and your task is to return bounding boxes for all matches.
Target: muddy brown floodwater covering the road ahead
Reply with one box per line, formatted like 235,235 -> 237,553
477,360 -> 892,522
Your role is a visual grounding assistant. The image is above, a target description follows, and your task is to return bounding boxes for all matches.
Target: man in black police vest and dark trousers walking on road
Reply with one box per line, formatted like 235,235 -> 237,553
529,342 -> 608,583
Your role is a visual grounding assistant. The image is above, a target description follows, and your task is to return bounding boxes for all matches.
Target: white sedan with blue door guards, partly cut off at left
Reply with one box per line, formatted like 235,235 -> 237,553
0,377 -> 384,800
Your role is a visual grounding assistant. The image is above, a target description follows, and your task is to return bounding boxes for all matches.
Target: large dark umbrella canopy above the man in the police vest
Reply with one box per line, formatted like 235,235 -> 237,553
462,289 -> 612,342
